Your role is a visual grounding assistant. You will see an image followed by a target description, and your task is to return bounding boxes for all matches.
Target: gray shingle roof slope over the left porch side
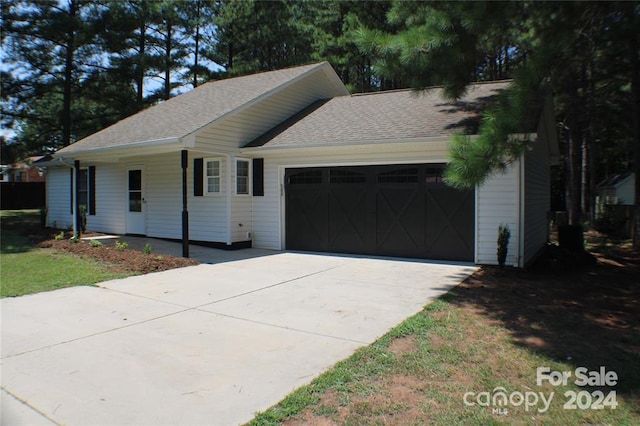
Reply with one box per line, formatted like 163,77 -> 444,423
58,63 -> 323,154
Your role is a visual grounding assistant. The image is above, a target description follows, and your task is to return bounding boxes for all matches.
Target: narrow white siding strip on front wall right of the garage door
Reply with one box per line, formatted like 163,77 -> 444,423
476,161 -> 520,266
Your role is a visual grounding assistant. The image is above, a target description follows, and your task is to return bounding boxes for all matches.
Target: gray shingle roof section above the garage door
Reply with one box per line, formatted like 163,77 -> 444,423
245,81 -> 510,147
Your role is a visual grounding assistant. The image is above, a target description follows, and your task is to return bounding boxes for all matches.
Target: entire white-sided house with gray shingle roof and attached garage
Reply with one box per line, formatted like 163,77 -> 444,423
42,62 -> 557,266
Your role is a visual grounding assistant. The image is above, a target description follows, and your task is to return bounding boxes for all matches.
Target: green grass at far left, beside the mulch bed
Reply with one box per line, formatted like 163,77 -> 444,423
0,210 -> 131,297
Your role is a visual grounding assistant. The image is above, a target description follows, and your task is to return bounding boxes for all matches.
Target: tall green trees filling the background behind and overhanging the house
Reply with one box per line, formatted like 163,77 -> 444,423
0,0 -> 640,244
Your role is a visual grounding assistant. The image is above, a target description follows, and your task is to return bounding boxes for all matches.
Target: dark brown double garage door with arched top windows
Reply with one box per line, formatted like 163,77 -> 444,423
285,164 -> 475,261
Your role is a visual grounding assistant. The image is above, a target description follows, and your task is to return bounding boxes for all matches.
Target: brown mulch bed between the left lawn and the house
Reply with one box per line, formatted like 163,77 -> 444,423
38,238 -> 199,274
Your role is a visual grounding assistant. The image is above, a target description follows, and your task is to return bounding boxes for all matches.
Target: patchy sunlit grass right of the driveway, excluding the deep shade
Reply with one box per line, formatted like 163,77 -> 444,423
249,264 -> 640,426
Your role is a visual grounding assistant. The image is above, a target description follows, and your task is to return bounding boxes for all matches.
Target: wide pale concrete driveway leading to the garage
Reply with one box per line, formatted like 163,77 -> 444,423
0,251 -> 476,425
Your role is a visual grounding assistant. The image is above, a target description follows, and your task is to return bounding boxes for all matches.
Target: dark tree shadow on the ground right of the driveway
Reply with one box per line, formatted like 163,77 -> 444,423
446,243 -> 640,411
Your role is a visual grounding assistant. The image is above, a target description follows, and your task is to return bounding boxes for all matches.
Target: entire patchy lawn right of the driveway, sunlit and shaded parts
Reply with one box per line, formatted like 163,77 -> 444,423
249,245 -> 640,426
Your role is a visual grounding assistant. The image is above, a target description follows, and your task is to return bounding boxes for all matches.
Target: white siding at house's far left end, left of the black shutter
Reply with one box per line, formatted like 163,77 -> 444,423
46,167 -> 73,229
